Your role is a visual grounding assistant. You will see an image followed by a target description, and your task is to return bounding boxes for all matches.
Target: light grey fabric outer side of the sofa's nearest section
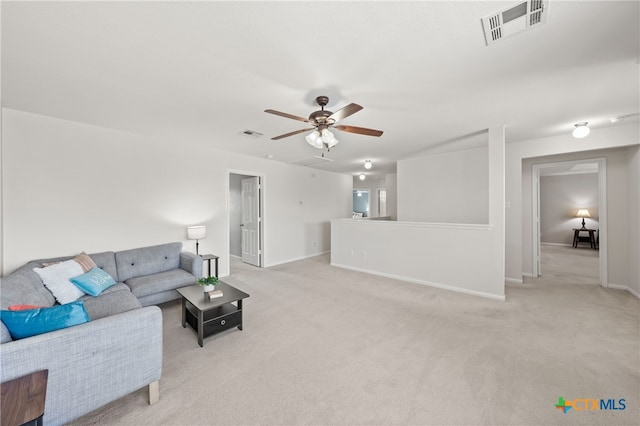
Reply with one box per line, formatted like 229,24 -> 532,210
0,306 -> 162,425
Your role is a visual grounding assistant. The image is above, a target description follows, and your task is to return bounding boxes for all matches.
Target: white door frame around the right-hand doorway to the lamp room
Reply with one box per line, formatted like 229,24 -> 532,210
531,157 -> 609,287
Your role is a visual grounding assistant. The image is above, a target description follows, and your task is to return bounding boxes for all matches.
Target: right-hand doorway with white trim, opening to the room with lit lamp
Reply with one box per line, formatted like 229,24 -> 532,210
531,158 -> 608,287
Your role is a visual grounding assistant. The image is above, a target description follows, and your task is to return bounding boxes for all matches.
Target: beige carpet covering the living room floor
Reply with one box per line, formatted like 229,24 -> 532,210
75,251 -> 640,425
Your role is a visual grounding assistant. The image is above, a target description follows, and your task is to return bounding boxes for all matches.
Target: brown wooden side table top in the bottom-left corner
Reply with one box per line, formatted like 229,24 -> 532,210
0,370 -> 49,426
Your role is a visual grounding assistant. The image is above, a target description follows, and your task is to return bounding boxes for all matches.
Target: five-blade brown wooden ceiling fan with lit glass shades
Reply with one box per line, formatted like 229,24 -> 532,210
264,96 -> 382,151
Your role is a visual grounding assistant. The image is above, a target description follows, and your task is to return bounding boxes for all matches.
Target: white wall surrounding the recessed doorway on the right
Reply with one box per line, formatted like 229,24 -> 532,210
505,123 -> 640,290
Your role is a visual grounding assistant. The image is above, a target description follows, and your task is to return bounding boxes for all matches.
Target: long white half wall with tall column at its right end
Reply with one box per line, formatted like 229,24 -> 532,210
331,127 -> 505,300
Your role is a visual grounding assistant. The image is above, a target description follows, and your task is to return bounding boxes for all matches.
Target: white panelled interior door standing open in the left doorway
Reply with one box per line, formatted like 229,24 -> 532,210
240,176 -> 262,266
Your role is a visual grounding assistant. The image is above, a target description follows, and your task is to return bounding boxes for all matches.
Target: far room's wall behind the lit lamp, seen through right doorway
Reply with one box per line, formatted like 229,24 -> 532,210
540,173 -> 599,245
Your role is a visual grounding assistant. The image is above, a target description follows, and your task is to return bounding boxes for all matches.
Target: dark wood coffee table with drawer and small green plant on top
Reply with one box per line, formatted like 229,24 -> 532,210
177,281 -> 249,347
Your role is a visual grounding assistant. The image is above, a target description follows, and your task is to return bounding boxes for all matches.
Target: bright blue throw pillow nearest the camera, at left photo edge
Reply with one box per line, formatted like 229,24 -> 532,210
0,300 -> 91,340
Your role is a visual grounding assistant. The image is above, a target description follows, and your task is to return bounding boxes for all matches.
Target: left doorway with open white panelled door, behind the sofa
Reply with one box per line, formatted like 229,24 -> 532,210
227,171 -> 264,273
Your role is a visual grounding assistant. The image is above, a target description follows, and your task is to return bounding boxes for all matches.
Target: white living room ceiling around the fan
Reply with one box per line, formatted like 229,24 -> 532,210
2,0 -> 640,174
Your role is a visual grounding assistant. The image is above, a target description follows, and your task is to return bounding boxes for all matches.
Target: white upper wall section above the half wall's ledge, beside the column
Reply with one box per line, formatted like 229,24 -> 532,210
398,147 -> 489,224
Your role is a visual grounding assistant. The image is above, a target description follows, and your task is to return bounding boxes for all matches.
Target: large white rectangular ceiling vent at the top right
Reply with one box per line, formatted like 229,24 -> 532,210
482,0 -> 549,46
